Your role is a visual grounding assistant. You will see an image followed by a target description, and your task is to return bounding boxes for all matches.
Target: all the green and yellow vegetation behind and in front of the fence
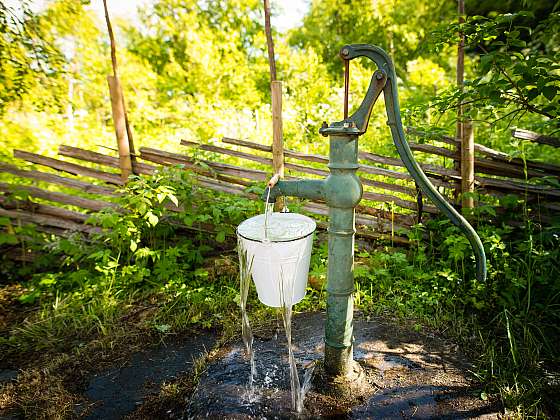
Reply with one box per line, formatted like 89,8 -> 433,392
0,0 -> 560,417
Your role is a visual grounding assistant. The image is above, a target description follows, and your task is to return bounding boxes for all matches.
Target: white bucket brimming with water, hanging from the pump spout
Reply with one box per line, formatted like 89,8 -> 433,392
237,213 -> 316,308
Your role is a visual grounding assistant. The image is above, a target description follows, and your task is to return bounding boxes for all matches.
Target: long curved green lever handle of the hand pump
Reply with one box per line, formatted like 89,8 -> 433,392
333,44 -> 486,281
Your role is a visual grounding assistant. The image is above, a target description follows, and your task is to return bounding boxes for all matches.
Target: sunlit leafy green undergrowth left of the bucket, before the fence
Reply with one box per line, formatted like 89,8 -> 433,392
0,169 -> 260,349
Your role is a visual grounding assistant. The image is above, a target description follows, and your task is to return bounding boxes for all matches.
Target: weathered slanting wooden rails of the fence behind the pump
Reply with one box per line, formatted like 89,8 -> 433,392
0,129 -> 560,260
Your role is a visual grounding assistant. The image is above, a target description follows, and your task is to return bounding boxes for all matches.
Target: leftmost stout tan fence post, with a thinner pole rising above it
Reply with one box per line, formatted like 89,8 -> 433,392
107,76 -> 132,182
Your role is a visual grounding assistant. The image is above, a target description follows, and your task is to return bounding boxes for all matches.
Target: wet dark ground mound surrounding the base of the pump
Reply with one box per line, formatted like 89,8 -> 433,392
189,314 -> 500,419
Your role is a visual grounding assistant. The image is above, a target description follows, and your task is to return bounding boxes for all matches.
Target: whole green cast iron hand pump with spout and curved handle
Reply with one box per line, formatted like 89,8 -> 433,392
265,44 -> 486,376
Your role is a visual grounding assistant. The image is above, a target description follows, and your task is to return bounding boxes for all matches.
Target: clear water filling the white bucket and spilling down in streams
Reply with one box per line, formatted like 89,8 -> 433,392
238,197 -> 315,413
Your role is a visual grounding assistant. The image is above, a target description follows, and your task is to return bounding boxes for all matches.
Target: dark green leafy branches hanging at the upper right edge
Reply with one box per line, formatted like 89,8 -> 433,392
426,12 -> 560,130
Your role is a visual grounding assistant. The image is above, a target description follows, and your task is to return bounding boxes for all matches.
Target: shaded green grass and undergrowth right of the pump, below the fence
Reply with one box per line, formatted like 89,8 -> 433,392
356,215 -> 560,416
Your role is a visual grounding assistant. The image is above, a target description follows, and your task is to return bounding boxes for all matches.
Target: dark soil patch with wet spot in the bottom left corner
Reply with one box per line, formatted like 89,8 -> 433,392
0,326 -> 216,419
